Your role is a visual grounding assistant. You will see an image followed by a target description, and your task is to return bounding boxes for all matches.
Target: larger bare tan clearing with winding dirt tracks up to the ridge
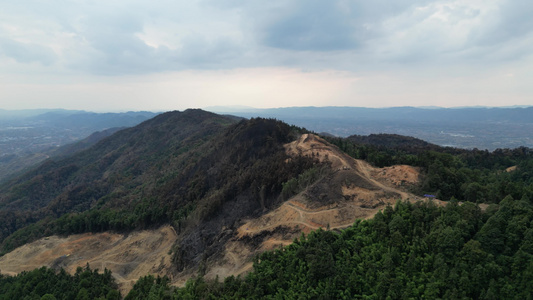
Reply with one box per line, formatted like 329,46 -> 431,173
202,134 -> 442,278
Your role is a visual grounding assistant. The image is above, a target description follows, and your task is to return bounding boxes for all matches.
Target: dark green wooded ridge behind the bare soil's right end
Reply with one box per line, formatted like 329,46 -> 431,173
327,134 -> 533,203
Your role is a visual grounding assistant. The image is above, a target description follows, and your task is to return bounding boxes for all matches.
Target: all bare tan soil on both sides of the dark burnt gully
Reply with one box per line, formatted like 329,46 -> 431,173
0,134 -> 438,294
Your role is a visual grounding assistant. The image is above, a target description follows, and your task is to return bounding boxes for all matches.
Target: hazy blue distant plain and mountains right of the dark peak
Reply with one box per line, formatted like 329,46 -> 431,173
208,106 -> 533,150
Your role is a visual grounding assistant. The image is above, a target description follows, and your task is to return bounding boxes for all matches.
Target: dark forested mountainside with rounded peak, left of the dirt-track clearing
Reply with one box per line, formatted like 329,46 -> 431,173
0,110 -> 314,271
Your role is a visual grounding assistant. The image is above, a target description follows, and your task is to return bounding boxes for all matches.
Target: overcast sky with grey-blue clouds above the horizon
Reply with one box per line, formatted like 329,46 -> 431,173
0,0 -> 533,111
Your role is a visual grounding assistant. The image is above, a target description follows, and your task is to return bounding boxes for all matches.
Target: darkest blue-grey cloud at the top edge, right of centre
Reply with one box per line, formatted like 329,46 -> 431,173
235,0 -> 434,52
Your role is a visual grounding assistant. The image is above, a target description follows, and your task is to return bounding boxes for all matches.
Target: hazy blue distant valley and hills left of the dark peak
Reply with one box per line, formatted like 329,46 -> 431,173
0,109 -> 157,181
